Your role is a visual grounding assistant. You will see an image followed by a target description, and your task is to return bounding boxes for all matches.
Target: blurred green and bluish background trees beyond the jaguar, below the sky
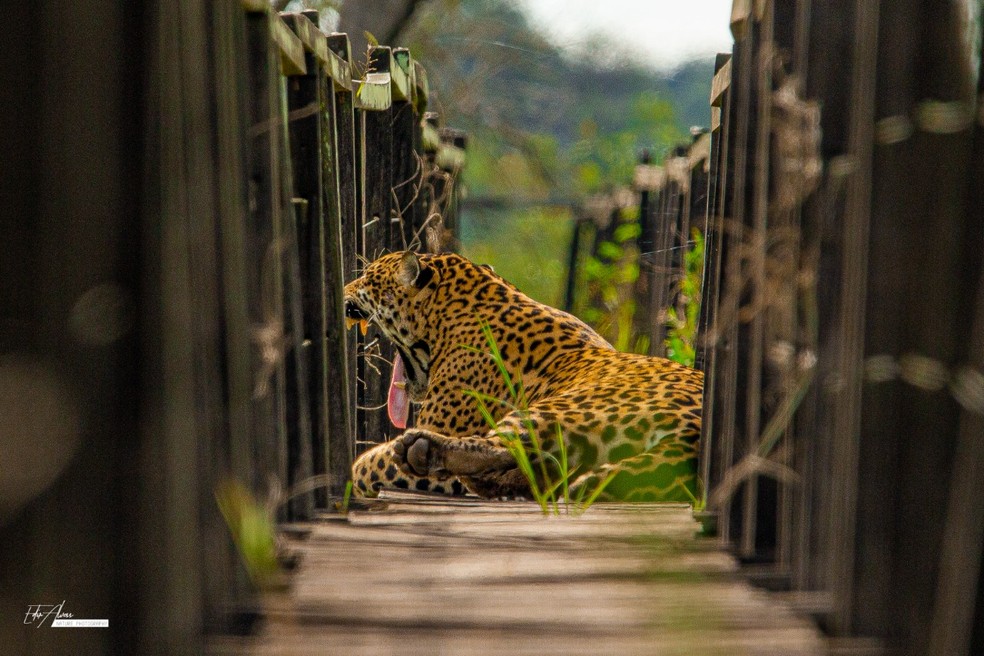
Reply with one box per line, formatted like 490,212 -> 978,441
401,0 -> 713,308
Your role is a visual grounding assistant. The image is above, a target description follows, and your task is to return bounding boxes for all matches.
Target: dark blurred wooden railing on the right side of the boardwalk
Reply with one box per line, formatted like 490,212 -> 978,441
702,0 -> 984,654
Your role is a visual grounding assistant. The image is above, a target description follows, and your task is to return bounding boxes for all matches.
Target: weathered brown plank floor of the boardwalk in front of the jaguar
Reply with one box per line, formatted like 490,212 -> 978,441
211,494 -> 824,656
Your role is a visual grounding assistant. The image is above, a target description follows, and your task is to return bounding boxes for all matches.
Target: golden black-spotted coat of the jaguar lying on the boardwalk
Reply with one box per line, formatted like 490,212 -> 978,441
345,252 -> 703,501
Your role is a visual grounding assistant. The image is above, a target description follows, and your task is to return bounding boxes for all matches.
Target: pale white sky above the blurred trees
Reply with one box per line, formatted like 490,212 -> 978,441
515,0 -> 733,68
